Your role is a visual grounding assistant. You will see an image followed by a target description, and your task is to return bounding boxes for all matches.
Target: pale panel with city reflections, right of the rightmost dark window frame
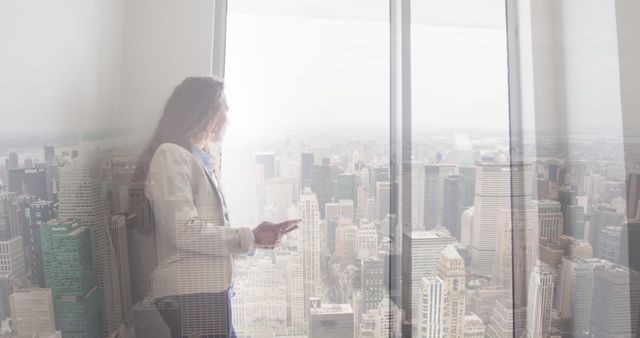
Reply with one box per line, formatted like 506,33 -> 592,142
514,1 -> 640,337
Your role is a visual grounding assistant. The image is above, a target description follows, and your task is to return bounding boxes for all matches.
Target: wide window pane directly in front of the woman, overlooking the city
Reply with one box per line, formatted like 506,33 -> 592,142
222,0 -> 390,337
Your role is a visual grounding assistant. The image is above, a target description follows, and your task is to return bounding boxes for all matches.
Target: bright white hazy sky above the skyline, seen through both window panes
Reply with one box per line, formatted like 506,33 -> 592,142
225,9 -> 508,142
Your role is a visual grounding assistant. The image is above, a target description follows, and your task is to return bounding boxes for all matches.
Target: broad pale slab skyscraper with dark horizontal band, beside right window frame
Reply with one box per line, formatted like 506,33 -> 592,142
471,162 -> 533,275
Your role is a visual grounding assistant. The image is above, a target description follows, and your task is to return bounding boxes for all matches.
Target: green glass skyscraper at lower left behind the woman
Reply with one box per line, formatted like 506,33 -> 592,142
40,219 -> 103,338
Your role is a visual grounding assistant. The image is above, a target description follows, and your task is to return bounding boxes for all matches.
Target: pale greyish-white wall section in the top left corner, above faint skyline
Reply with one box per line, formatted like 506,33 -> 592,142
0,0 -> 123,136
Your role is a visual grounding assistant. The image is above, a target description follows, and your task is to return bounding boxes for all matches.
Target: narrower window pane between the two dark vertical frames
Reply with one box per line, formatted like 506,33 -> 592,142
402,0 -> 512,337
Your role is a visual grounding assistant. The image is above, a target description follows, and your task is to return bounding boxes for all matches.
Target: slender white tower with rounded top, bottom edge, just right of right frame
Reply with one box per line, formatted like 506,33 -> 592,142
526,263 -> 553,338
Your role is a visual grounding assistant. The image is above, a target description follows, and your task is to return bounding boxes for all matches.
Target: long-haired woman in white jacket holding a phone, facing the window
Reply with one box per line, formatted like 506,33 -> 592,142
133,77 -> 298,337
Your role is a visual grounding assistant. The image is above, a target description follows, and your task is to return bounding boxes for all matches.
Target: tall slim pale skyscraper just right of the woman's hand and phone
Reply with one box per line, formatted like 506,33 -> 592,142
298,189 -> 323,320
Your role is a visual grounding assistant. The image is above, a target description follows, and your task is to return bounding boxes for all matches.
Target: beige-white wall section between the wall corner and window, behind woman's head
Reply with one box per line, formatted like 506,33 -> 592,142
120,0 -> 219,134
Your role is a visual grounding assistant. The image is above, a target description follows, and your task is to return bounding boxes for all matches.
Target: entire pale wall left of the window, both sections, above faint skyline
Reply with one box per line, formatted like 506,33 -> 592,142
0,0 -> 214,138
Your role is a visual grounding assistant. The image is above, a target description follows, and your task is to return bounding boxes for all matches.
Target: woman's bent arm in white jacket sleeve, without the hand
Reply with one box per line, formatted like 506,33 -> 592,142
146,144 -> 254,256
